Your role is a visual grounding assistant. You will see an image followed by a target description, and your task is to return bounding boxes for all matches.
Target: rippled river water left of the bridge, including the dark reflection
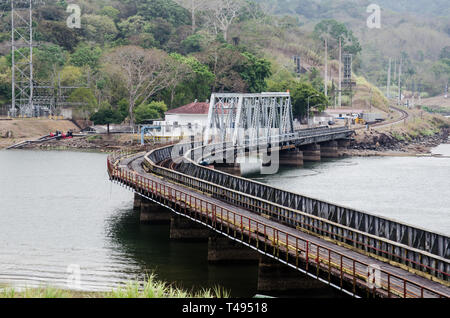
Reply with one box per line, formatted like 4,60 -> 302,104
0,151 -> 257,296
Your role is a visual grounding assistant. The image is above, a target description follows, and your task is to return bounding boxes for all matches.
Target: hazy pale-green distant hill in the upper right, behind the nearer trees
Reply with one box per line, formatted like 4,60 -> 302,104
256,0 -> 450,95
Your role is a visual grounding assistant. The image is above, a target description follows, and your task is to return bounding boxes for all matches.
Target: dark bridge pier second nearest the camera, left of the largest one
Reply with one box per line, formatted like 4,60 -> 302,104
208,233 -> 259,264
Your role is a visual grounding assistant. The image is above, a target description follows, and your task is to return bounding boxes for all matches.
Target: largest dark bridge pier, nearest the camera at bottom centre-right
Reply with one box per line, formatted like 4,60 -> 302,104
257,256 -> 340,298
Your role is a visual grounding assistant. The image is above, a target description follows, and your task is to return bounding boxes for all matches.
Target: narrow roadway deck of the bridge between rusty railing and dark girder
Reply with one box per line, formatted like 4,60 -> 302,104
120,154 -> 450,297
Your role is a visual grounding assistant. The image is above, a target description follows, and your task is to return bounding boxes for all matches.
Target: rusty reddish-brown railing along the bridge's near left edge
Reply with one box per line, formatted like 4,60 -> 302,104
107,158 -> 448,298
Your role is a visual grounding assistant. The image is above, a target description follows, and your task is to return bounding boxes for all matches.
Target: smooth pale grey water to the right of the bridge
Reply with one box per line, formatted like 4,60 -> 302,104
254,144 -> 450,235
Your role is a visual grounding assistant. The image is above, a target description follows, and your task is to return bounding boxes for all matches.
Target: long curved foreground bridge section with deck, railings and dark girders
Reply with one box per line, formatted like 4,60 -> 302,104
108,126 -> 450,298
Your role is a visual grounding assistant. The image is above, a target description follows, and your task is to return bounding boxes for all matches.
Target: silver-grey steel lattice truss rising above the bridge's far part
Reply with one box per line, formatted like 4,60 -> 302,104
204,93 -> 294,145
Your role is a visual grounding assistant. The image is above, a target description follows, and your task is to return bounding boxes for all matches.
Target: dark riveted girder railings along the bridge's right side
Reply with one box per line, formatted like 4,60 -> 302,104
145,133 -> 450,284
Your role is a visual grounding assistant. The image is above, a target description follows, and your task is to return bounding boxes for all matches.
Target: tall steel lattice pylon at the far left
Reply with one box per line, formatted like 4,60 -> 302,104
10,0 -> 35,117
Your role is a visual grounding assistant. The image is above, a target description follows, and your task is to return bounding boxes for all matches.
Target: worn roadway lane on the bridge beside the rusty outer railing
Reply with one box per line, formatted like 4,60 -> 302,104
120,153 -> 450,297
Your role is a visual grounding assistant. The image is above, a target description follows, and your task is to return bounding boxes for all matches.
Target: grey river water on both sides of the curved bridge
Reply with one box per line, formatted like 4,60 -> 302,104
0,145 -> 450,297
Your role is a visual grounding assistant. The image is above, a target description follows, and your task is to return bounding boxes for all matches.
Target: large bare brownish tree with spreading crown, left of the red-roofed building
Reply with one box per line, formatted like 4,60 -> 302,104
106,46 -> 173,125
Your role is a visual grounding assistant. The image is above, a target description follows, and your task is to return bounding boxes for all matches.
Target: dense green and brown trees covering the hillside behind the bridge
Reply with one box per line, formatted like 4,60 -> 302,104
0,0 -> 450,122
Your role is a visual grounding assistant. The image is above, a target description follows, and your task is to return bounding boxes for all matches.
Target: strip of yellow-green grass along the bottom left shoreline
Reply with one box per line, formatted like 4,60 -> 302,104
0,275 -> 230,298
